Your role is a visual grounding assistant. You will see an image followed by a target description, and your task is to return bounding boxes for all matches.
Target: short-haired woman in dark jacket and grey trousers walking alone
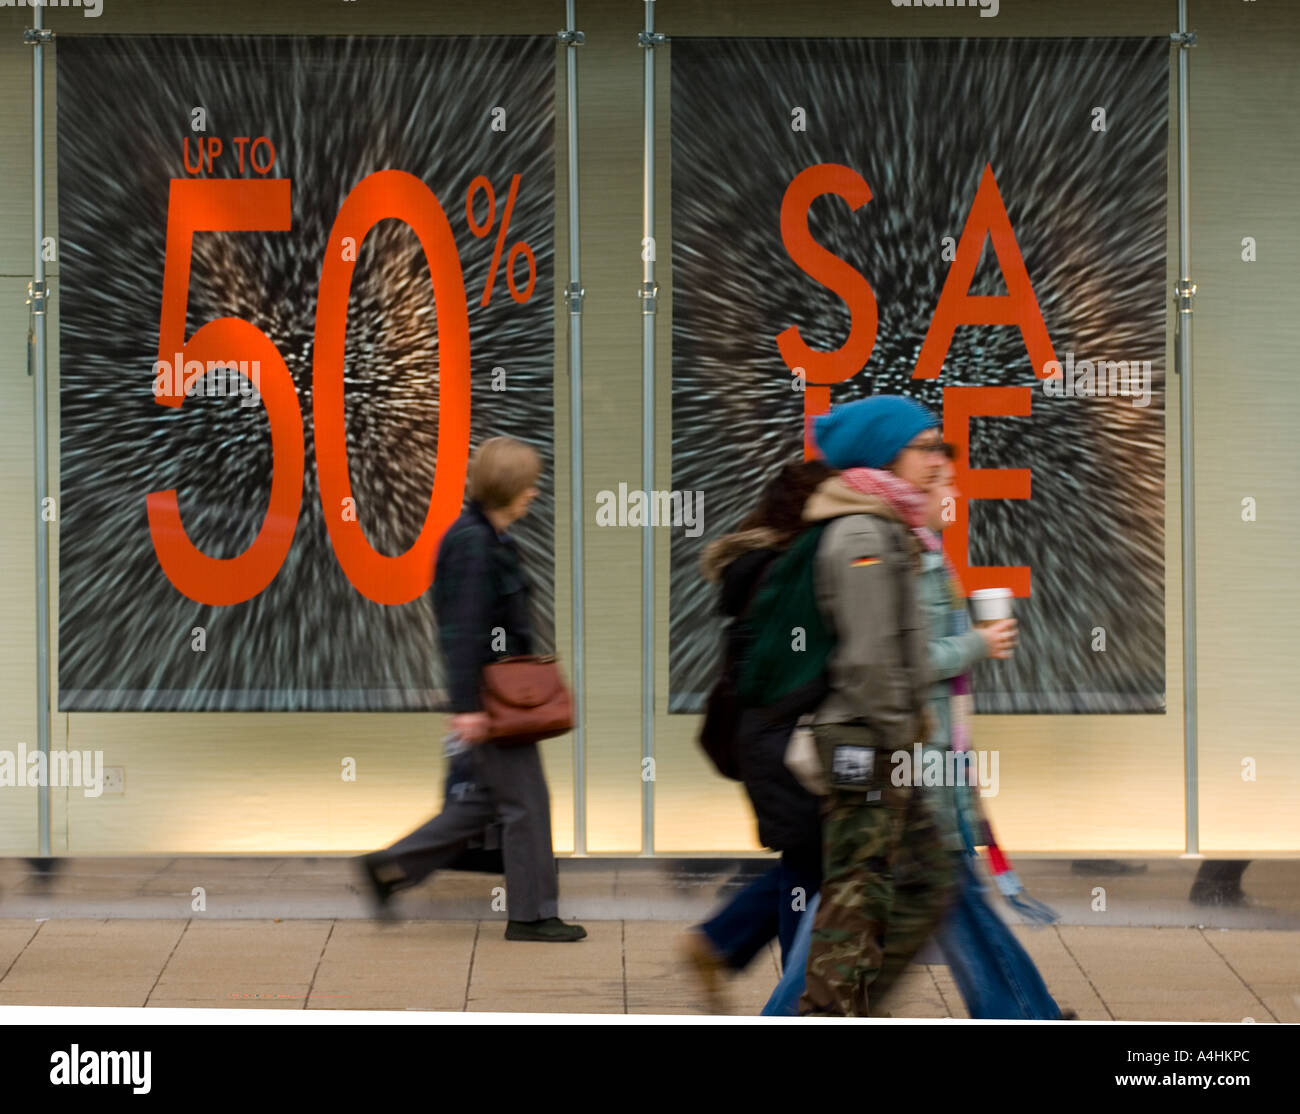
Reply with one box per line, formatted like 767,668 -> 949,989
360,437 -> 586,942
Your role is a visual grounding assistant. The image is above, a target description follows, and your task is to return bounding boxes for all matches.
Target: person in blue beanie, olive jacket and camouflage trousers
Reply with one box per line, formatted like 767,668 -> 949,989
774,395 -> 957,1017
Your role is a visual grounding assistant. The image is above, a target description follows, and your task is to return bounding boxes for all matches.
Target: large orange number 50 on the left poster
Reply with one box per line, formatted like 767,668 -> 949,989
146,170 -> 469,604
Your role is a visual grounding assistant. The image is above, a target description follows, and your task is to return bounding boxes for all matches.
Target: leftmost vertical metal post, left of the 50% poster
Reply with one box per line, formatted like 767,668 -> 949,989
23,6 -> 51,858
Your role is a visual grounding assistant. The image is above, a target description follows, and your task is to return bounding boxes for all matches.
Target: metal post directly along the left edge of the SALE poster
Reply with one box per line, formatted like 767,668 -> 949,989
638,0 -> 666,855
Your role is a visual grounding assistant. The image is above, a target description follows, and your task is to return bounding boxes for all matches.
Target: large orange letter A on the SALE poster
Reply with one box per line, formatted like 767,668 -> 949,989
911,164 -> 1056,380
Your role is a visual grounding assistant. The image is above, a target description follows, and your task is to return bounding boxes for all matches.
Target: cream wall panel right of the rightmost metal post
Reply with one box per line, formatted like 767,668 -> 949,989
1191,3 -> 1300,853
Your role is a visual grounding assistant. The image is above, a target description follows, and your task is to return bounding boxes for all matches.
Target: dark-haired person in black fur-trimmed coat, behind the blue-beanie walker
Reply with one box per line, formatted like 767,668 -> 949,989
684,460 -> 832,1013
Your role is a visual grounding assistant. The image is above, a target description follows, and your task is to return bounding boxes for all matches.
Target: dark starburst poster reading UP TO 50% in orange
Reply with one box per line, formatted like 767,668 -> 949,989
59,36 -> 554,711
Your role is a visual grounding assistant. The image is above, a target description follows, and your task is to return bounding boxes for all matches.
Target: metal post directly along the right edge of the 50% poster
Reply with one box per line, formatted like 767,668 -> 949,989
559,0 -> 586,855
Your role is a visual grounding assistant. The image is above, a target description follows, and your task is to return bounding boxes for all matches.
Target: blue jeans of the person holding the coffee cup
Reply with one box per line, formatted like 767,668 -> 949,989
763,854 -> 1061,1020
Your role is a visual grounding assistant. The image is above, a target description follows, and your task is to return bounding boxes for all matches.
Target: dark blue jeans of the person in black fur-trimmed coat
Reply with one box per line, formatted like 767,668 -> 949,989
699,849 -> 822,971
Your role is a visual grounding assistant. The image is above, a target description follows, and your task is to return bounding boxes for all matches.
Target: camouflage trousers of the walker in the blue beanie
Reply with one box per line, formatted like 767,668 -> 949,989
800,724 -> 957,1018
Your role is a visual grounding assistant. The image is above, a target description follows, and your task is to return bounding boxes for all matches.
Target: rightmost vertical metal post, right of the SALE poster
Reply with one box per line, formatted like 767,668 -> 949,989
1173,0 -> 1200,855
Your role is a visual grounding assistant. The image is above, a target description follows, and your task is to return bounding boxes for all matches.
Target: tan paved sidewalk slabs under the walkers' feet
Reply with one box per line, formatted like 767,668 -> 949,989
0,918 -> 1300,1022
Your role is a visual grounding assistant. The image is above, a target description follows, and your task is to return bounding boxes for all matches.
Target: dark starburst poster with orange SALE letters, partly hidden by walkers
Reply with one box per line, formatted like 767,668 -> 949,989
670,38 -> 1169,712
